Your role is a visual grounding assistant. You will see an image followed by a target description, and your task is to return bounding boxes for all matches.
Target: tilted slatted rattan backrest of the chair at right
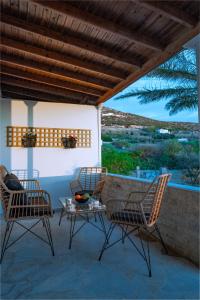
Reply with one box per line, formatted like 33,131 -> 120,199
142,174 -> 171,226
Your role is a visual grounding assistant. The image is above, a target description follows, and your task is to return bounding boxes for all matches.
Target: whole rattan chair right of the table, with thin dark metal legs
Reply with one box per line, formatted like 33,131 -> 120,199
99,174 -> 171,277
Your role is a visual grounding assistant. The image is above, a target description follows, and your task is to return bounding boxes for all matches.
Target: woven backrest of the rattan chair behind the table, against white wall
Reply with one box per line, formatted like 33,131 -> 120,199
78,167 -> 107,191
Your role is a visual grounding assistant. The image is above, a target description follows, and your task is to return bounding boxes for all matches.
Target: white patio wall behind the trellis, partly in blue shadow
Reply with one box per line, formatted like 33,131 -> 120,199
0,99 -> 101,207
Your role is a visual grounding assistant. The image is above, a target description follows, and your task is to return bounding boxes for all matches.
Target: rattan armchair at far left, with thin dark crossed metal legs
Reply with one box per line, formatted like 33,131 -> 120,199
0,165 -> 54,262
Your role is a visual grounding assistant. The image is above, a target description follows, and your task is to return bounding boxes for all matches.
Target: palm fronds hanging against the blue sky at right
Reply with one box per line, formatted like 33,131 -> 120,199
115,49 -> 198,115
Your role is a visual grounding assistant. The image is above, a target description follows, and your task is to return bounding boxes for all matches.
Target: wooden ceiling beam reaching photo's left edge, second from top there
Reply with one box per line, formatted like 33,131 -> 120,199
0,36 -> 127,79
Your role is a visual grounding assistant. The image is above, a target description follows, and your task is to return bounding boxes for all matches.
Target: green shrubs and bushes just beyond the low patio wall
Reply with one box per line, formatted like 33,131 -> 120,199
102,139 -> 200,185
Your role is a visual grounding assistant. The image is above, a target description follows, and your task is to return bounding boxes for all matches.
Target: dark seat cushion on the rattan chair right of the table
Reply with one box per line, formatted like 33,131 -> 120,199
110,209 -> 149,225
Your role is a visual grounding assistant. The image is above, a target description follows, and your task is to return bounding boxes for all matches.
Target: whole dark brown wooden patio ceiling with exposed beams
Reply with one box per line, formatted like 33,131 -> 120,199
0,0 -> 200,105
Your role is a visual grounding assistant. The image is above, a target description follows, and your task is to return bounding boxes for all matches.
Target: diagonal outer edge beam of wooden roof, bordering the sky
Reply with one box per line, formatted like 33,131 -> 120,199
97,23 -> 200,104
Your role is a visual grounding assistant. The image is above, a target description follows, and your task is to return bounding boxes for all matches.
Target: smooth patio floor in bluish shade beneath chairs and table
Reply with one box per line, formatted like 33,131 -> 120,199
1,213 -> 199,299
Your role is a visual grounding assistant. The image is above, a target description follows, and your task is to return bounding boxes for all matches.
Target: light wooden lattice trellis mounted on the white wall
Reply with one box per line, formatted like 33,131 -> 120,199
7,126 -> 91,148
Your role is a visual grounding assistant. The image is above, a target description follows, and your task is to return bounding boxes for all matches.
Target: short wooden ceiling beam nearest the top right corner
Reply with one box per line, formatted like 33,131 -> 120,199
135,0 -> 198,28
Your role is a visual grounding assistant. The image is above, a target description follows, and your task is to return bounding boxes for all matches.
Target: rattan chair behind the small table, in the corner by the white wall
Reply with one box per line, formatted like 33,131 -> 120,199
59,167 -> 107,226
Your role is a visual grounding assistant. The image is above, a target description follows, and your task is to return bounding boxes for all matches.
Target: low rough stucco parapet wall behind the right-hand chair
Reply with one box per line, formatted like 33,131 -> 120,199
102,175 -> 199,265
